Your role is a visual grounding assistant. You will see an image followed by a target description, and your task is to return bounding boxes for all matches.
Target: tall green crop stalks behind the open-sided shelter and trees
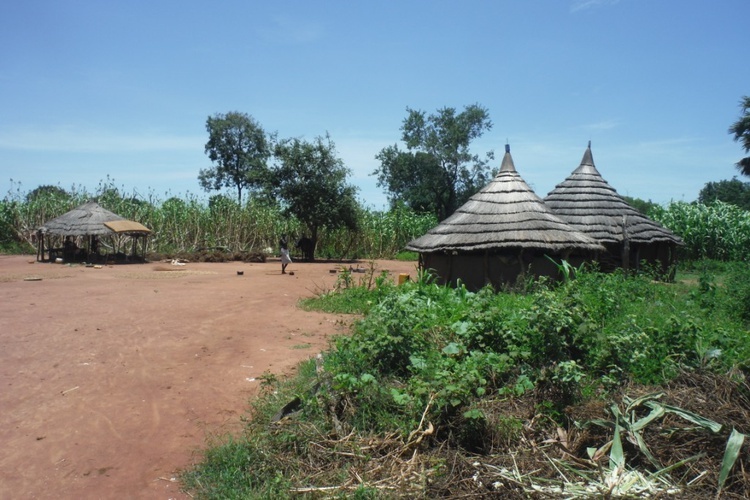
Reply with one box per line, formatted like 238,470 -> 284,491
0,177 -> 437,259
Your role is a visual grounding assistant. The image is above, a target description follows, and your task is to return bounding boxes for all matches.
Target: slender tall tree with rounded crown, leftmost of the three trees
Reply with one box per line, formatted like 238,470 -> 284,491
198,111 -> 272,204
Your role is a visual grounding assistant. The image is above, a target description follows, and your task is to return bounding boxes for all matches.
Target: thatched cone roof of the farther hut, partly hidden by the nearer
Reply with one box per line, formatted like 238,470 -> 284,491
544,142 -> 682,244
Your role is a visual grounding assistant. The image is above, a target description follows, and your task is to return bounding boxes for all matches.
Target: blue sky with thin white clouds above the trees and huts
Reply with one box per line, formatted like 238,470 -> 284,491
0,0 -> 750,208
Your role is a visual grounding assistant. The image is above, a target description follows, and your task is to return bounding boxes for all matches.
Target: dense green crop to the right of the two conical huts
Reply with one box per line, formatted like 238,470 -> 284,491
649,201 -> 750,261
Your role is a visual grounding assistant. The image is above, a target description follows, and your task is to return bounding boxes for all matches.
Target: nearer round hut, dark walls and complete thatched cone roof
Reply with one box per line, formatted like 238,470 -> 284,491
406,145 -> 603,290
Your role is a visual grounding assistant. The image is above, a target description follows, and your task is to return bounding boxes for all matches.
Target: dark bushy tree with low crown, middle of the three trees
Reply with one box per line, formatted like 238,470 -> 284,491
272,134 -> 357,255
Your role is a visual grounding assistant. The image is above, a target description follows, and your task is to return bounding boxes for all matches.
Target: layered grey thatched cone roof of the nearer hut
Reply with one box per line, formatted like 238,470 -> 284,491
406,145 -> 602,253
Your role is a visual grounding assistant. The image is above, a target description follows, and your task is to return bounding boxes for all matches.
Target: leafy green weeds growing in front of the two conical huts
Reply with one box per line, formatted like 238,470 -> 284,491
318,266 -> 750,436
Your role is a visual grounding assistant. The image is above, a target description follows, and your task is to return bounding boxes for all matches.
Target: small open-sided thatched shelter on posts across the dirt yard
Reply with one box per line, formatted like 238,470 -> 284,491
37,202 -> 151,261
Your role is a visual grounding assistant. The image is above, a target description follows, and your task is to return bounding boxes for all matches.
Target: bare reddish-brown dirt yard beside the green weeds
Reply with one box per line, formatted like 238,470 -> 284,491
0,256 -> 415,499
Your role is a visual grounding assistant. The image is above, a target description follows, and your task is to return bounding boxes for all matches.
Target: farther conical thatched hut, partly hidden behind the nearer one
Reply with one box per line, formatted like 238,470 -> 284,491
544,142 -> 683,276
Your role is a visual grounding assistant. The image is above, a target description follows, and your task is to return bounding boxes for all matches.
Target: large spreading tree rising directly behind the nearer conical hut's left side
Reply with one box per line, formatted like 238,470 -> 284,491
374,104 -> 494,220
